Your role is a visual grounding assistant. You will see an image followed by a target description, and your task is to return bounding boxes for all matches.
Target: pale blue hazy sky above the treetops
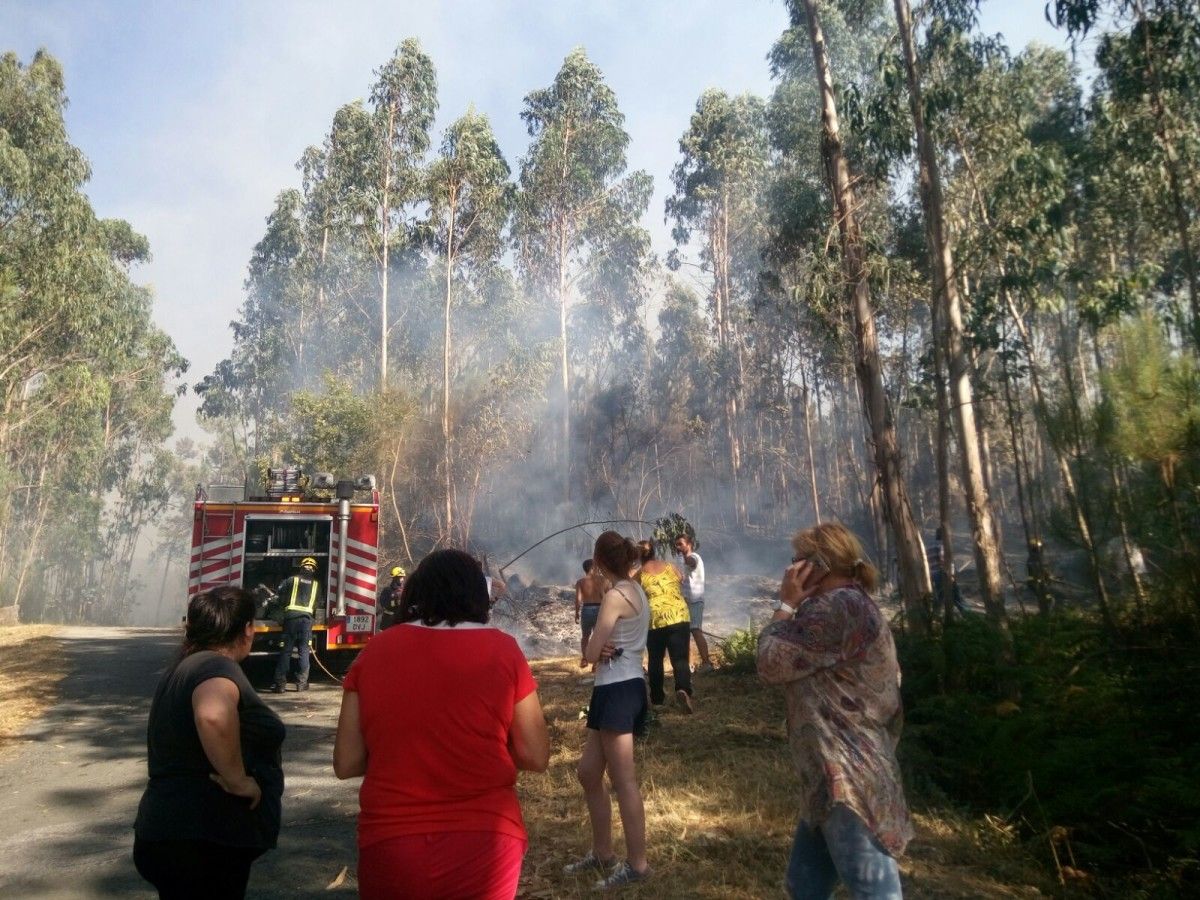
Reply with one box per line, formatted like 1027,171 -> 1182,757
0,0 -> 1066,436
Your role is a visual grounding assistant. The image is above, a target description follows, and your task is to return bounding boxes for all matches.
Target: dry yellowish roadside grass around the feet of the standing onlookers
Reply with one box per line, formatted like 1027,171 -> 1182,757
518,659 -> 1055,900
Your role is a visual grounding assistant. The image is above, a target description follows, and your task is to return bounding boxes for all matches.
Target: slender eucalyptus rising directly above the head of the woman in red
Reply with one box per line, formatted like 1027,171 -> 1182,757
426,109 -> 512,542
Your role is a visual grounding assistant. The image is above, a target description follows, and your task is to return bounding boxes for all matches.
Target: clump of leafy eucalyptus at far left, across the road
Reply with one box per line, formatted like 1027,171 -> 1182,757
0,53 -> 186,612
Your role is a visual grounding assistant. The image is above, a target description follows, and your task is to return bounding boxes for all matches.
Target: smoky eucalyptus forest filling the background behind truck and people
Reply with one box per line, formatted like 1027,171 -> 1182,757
0,0 -> 1200,896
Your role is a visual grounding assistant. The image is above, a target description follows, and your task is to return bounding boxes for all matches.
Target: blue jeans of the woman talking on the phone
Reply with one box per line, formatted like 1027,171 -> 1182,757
787,803 -> 902,900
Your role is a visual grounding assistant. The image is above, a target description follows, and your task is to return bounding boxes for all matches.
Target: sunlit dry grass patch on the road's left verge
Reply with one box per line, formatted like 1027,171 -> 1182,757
0,625 -> 66,754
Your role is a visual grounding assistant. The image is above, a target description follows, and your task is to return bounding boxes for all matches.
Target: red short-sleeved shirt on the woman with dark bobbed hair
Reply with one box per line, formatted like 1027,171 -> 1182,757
343,623 -> 538,847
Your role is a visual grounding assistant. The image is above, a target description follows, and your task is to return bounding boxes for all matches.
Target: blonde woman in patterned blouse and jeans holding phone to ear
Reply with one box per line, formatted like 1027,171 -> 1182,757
758,523 -> 912,900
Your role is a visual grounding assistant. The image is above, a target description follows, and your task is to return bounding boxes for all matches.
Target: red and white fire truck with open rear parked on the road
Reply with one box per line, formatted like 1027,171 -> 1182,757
187,467 -> 379,668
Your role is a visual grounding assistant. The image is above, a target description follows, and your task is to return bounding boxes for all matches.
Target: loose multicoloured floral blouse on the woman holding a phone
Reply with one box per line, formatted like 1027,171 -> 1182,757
758,584 -> 912,857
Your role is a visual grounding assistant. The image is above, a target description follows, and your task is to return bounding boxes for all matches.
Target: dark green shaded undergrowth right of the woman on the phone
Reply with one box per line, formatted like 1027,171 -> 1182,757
898,604 -> 1200,888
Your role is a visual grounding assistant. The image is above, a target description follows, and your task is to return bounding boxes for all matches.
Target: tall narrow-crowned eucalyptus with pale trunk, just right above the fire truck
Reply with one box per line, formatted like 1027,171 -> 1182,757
371,37 -> 438,392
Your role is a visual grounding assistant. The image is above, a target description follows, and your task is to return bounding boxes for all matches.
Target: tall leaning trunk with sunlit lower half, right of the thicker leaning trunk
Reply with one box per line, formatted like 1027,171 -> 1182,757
894,0 -> 1006,623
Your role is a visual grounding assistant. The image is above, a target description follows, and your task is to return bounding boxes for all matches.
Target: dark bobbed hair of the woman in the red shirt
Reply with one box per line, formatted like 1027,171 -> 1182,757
396,550 -> 491,625
